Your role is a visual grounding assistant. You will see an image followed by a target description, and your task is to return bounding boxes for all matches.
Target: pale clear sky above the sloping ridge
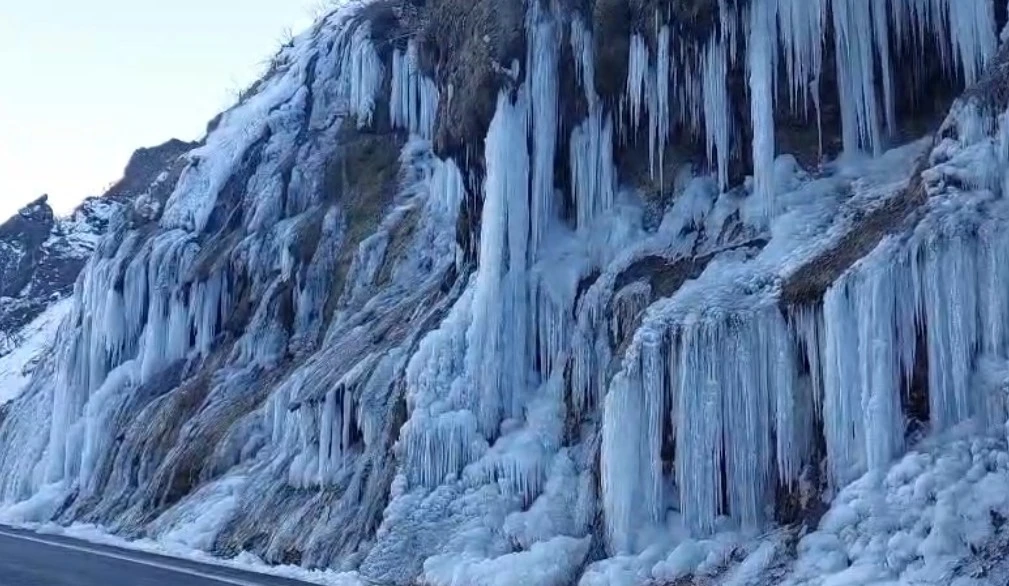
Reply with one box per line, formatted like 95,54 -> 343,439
0,0 -> 321,222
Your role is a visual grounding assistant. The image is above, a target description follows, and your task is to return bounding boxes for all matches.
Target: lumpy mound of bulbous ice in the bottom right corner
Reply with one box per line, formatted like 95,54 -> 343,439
785,424 -> 1009,586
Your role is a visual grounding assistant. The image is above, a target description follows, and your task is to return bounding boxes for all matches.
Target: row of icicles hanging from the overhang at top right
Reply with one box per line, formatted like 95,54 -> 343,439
617,0 -> 997,219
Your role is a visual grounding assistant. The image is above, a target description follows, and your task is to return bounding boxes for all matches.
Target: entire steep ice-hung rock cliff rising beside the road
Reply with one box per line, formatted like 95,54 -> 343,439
0,0 -> 1009,586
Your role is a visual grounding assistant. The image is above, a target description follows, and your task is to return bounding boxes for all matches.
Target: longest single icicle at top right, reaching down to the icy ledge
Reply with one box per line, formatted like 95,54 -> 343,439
749,0 -> 777,222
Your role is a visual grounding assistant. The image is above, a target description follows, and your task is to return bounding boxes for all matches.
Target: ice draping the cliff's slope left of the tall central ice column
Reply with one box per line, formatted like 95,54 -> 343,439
0,4 -> 462,564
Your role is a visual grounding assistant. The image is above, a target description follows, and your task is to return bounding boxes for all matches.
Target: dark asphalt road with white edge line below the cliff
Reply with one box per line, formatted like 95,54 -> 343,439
0,526 -> 314,586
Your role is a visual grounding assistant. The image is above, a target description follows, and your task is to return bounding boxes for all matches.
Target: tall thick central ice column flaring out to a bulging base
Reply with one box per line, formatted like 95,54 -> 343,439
393,3 -> 573,500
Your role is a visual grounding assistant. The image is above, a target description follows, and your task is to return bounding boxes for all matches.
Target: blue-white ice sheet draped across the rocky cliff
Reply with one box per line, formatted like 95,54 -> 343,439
0,0 -> 1009,586
